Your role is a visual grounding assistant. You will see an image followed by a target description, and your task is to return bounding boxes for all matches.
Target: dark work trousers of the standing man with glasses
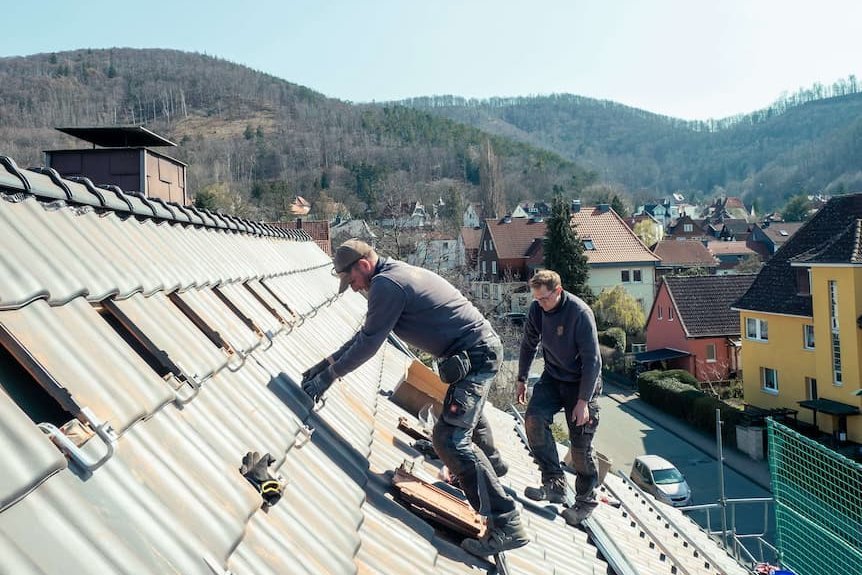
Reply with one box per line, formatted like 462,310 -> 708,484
524,373 -> 599,507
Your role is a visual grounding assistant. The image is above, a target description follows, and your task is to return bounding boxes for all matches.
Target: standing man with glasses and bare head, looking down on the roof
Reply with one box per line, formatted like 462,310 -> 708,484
517,270 -> 602,525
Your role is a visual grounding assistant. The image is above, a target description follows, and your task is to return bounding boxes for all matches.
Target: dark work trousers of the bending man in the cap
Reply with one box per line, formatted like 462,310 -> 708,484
433,338 -> 517,524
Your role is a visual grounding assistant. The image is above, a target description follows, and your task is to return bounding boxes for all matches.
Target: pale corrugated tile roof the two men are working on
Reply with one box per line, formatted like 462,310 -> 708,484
0,162 -> 748,575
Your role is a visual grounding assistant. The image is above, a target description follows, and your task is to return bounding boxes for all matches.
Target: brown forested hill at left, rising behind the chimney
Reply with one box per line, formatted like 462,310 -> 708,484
0,49 -> 595,225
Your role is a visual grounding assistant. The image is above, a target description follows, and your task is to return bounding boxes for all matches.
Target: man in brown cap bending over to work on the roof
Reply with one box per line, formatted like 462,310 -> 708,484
302,239 -> 529,556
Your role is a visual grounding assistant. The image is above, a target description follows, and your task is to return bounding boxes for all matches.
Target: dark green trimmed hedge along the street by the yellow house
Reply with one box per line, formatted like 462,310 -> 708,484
638,370 -> 743,445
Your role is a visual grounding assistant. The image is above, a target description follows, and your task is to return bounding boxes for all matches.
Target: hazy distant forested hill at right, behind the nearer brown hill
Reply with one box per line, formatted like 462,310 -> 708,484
401,86 -> 862,209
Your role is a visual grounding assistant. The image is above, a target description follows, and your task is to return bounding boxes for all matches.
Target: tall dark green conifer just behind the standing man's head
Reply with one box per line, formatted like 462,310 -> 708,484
542,194 -> 594,303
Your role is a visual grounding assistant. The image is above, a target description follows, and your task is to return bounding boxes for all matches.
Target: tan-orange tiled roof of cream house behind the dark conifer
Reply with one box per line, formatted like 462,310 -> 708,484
572,208 -> 659,264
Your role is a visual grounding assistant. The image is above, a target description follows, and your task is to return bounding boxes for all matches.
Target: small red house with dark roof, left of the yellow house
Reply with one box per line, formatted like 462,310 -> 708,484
635,276 -> 755,381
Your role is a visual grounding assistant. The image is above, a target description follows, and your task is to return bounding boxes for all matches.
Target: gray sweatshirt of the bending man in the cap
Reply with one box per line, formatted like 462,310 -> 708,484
332,258 -> 495,377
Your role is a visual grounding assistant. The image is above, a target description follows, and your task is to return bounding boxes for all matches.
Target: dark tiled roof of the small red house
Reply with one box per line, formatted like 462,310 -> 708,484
664,274 -> 756,337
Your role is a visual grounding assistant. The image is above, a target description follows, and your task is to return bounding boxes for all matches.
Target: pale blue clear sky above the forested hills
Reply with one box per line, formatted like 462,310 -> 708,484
0,0 -> 862,119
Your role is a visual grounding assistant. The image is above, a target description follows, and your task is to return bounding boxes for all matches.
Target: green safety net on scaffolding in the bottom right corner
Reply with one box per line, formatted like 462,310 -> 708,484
767,419 -> 862,575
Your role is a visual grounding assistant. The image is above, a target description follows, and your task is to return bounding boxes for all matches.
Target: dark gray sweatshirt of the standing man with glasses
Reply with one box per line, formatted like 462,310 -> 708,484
518,291 -> 602,401
